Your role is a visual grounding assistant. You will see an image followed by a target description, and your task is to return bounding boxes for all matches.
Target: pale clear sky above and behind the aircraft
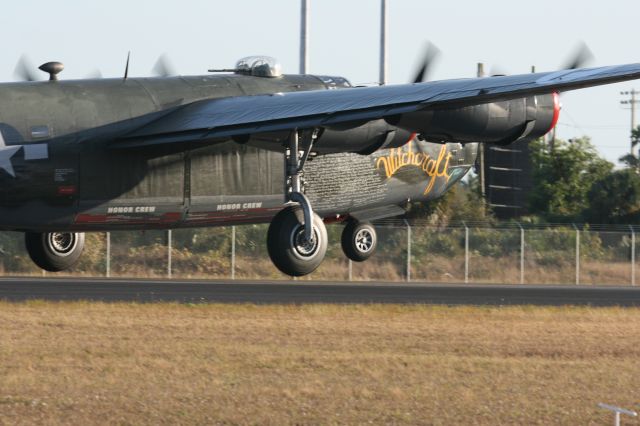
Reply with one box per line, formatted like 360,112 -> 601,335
0,0 -> 640,161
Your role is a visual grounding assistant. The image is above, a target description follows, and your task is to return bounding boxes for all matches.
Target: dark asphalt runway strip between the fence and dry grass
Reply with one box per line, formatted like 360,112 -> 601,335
0,278 -> 640,306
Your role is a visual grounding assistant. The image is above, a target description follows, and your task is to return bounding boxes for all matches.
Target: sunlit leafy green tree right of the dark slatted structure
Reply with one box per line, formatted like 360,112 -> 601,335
529,137 -> 613,222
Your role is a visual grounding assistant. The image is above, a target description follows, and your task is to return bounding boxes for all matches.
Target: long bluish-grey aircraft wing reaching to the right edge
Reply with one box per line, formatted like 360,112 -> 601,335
114,64 -> 640,151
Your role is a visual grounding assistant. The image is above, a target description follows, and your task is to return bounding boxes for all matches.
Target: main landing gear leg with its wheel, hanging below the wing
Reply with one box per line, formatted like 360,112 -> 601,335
267,129 -> 327,276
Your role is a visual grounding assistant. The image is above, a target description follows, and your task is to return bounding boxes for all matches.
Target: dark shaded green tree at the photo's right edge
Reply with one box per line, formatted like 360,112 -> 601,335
584,169 -> 640,224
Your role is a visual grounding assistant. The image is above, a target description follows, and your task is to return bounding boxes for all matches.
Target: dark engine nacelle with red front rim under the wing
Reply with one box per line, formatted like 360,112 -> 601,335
391,93 -> 560,145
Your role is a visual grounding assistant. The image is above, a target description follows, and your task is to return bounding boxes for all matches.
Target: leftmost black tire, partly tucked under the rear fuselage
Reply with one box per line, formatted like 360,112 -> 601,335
24,232 -> 84,272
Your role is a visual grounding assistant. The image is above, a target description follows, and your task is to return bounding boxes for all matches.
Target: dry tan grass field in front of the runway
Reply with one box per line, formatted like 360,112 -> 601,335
0,302 -> 640,425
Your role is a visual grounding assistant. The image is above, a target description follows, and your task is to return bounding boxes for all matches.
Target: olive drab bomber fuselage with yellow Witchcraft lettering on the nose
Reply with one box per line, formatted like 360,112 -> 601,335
0,74 -> 477,231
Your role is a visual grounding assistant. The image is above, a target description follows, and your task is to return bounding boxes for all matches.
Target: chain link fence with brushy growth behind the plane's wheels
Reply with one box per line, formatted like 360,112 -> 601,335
0,220 -> 640,286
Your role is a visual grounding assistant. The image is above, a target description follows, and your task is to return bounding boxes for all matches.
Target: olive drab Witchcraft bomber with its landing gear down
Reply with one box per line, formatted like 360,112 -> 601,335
0,57 -> 640,276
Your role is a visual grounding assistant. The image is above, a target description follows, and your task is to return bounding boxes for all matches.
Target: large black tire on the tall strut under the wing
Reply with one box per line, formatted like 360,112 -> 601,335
267,206 -> 327,277
